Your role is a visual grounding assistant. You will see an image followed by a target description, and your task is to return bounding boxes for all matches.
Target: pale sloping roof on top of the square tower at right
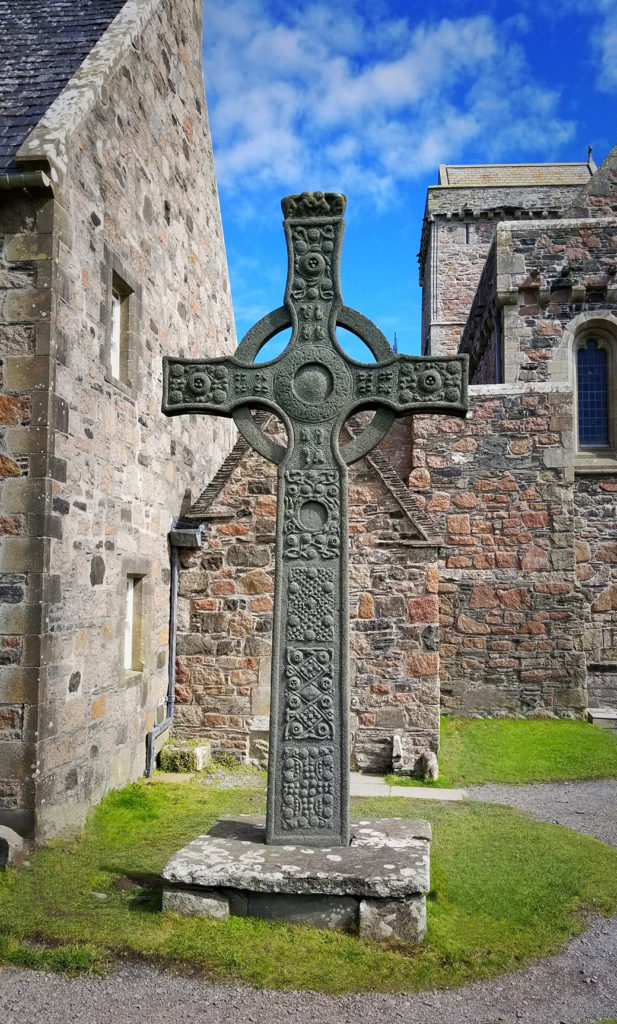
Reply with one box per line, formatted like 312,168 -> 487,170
439,163 -> 592,187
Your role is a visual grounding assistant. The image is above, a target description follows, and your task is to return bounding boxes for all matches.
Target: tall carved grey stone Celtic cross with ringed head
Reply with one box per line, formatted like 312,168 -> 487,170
163,193 -> 467,847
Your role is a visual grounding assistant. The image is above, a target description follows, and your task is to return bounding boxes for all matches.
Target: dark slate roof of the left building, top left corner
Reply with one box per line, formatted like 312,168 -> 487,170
0,0 -> 126,171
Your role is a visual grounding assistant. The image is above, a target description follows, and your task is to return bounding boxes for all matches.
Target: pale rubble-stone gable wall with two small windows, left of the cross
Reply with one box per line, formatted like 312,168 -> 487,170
0,0 -> 234,839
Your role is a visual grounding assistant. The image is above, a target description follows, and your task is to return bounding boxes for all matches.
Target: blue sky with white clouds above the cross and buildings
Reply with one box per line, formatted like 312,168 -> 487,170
204,0 -> 617,358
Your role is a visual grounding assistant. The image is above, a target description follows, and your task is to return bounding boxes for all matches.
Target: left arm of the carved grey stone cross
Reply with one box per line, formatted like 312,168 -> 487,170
163,356 -> 274,416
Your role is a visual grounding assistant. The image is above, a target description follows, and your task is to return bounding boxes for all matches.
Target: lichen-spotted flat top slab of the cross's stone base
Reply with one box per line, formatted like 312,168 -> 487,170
163,815 -> 431,899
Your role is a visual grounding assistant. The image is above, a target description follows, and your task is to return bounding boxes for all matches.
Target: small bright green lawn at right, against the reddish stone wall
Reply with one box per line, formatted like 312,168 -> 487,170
387,718 -> 617,788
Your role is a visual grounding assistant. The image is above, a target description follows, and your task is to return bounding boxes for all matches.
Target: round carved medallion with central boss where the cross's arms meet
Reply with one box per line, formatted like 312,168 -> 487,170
274,346 -> 352,423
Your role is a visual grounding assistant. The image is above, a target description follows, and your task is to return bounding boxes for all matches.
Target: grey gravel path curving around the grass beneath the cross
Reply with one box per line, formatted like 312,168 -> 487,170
0,781 -> 617,1024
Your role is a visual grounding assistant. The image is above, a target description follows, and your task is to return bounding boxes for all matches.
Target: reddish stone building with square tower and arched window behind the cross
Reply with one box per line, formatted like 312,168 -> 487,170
176,151 -> 617,770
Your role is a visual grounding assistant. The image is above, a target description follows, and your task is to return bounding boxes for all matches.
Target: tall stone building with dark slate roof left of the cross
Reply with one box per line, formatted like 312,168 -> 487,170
0,0 -> 235,854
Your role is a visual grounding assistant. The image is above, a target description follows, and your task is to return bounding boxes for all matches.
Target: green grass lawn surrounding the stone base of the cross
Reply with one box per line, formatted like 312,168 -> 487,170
0,780 -> 617,992
